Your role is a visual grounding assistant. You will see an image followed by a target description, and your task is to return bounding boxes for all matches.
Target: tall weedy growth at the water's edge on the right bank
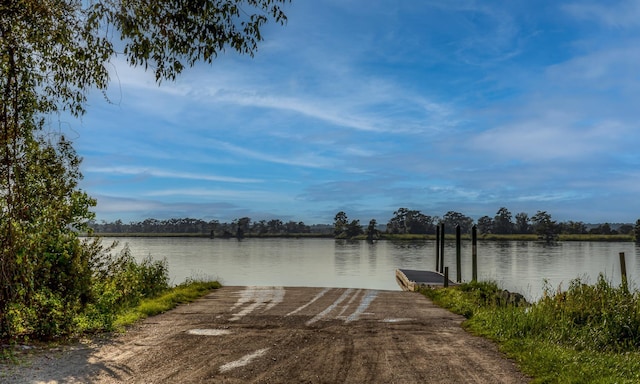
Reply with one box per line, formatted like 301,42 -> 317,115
460,275 -> 640,352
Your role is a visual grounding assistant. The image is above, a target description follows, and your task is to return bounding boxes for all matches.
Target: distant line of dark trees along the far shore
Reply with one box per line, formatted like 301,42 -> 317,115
89,207 -> 640,238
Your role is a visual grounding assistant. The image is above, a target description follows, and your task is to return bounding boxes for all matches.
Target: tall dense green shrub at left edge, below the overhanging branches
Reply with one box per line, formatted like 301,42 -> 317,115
0,137 -> 95,338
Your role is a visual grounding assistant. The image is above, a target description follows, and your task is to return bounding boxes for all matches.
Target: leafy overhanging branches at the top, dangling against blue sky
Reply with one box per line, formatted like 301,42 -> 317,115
88,0 -> 288,81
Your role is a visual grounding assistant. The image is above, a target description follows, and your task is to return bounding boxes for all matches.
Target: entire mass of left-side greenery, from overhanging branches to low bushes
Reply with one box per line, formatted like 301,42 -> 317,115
0,0 -> 288,339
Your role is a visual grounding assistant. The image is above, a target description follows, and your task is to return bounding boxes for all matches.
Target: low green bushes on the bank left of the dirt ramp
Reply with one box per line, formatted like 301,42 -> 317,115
5,240 -> 169,340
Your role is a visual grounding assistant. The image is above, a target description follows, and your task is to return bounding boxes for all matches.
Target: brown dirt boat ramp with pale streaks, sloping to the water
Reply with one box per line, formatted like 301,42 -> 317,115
0,287 -> 529,384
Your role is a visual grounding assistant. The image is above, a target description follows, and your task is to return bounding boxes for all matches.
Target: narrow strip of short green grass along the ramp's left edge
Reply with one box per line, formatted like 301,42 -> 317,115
114,280 -> 221,329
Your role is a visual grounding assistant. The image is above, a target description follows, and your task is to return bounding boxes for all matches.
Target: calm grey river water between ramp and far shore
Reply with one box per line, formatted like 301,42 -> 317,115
105,238 -> 640,299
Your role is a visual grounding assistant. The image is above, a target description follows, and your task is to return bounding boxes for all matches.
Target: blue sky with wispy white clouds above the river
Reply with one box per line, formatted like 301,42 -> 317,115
61,0 -> 640,224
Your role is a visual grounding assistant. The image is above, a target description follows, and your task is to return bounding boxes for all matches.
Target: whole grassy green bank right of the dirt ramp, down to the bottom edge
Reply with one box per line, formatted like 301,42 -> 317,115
422,276 -> 640,383
